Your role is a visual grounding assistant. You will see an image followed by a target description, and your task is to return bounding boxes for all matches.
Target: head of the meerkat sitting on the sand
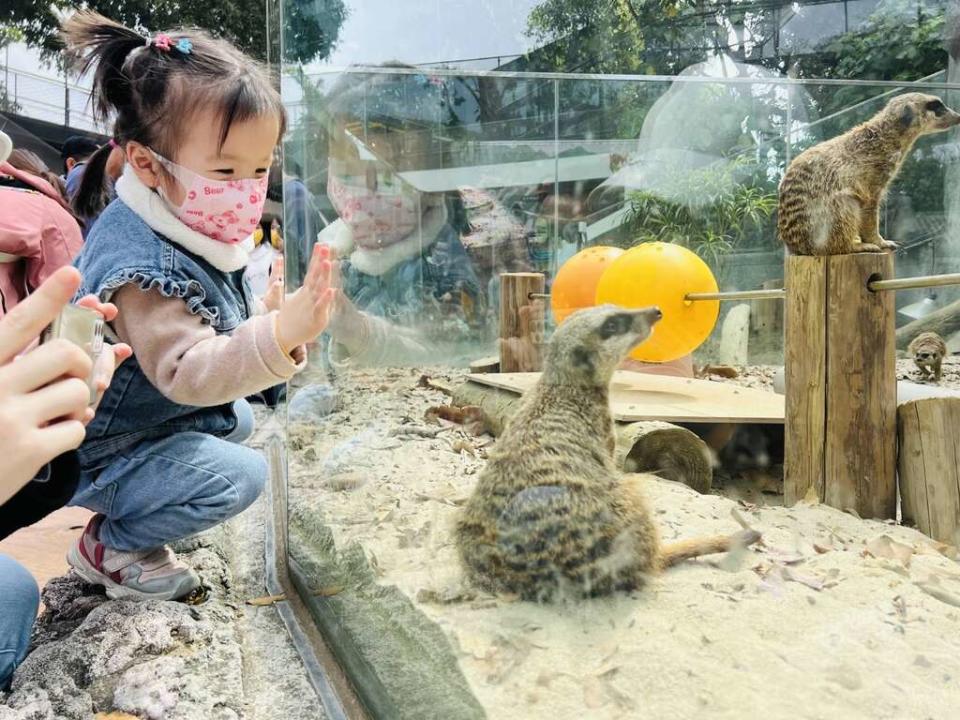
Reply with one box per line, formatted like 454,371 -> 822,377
547,305 -> 663,385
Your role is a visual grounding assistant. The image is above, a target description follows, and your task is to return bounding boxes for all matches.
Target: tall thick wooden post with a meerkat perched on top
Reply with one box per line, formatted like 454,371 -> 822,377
784,253 -> 897,518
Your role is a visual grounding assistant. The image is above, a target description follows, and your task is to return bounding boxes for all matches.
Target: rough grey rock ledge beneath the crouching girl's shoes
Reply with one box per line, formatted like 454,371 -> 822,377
0,408 -> 324,720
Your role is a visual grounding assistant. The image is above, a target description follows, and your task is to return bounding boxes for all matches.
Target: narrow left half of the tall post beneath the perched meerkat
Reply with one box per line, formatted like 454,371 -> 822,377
783,256 -> 827,505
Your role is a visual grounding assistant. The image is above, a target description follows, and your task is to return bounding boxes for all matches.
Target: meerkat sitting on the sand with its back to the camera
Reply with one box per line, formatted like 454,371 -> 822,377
455,305 -> 760,602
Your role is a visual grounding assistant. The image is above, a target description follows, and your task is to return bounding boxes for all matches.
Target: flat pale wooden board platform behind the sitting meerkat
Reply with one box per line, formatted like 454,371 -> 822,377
469,371 -> 784,424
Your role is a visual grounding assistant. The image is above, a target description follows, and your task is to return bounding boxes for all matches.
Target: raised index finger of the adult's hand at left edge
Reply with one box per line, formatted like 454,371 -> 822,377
0,267 -> 81,365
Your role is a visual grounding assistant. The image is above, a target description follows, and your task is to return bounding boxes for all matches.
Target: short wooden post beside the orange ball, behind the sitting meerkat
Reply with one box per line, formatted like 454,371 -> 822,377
500,273 -> 546,373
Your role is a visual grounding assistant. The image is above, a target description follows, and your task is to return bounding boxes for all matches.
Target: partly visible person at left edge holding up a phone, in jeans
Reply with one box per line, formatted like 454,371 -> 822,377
0,267 -> 130,691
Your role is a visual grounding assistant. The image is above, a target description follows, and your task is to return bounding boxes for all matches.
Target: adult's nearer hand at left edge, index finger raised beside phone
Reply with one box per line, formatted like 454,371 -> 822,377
0,267 -> 93,504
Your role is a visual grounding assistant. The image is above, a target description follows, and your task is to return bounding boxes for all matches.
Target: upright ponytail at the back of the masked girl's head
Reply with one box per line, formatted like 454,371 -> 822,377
62,10 -> 147,120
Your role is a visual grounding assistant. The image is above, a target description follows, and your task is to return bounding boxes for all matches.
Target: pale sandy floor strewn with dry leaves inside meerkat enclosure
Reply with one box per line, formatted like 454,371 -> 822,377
290,363 -> 960,720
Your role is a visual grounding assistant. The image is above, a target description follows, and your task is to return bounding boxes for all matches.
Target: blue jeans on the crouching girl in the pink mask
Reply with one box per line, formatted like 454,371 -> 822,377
70,400 -> 267,552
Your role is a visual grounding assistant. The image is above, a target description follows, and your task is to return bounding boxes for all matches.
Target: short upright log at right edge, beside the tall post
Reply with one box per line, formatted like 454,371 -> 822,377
897,398 -> 960,546
